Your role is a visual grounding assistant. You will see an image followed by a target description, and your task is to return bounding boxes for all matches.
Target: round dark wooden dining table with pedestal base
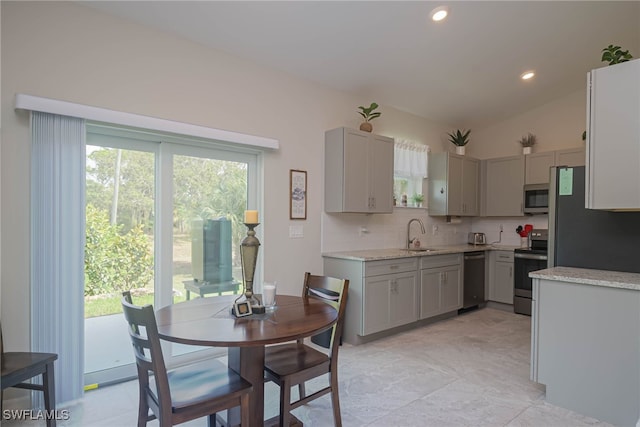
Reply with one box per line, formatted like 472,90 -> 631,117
156,295 -> 338,426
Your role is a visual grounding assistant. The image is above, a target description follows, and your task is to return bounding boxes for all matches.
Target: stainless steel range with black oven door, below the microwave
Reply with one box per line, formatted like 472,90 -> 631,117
513,229 -> 549,316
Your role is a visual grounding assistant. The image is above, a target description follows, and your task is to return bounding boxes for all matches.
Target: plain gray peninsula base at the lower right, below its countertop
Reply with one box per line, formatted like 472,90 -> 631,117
531,278 -> 640,426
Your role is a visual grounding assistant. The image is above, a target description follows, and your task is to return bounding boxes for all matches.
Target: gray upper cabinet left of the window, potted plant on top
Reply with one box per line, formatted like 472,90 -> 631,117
324,128 -> 393,213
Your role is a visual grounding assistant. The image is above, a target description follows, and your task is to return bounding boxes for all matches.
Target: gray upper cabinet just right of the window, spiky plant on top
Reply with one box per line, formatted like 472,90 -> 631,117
428,152 -> 480,216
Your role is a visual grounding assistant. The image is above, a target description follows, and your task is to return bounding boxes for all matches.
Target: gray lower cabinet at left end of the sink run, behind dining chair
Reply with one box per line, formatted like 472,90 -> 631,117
324,257 -> 419,345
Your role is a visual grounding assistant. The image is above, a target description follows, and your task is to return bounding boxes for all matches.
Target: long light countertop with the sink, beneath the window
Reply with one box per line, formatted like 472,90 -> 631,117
322,244 -> 519,261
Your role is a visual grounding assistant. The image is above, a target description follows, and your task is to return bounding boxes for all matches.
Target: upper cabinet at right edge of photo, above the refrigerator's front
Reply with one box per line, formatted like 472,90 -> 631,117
585,59 -> 640,210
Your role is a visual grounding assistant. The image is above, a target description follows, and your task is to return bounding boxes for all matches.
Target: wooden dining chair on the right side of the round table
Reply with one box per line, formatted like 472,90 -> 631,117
264,273 -> 349,427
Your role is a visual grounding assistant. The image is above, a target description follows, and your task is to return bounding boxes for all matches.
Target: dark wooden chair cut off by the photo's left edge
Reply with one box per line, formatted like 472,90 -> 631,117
0,325 -> 58,427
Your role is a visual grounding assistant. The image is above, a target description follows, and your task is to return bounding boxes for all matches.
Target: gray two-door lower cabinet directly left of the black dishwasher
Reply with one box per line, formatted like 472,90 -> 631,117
420,254 -> 462,319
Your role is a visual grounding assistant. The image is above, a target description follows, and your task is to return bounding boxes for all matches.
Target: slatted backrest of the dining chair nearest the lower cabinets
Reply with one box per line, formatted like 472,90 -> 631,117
302,272 -> 349,359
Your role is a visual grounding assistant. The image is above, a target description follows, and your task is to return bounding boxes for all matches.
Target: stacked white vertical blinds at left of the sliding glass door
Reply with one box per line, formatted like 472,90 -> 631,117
31,111 -> 86,407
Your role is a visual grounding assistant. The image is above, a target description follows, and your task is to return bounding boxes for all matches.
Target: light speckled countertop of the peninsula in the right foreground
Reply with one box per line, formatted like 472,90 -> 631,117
529,267 -> 640,291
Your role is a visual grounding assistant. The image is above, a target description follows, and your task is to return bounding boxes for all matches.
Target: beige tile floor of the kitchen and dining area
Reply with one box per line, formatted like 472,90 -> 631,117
3,308 -> 609,427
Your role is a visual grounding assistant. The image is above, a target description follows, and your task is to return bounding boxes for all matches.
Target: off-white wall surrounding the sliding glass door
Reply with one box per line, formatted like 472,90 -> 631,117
0,1 -> 449,348
